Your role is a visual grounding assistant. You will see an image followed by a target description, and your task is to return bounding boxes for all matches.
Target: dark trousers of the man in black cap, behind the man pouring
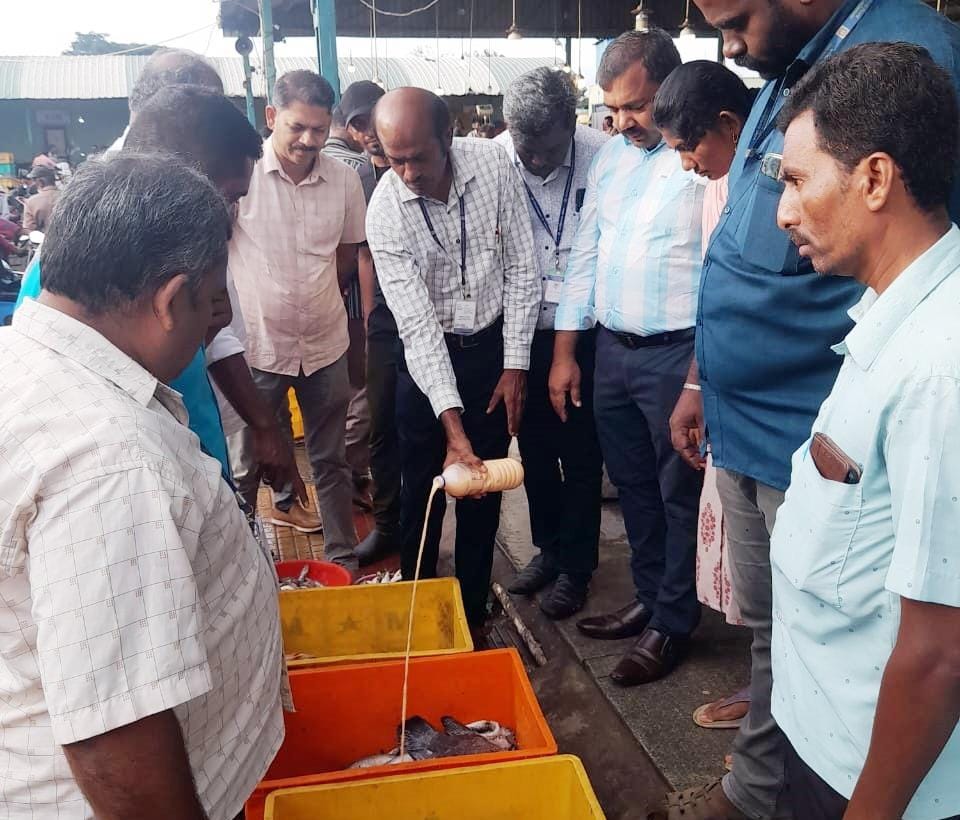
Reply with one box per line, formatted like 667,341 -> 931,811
367,330 -> 402,536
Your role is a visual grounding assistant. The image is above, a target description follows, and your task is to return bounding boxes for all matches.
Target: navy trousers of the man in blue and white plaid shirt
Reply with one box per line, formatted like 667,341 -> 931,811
594,328 -> 703,636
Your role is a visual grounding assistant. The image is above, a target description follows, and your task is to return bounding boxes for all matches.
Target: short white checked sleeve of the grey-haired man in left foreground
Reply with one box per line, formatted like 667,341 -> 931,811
27,467 -> 212,744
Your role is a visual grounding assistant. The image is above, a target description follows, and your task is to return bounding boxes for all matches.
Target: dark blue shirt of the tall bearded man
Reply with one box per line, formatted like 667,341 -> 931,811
697,0 -> 960,489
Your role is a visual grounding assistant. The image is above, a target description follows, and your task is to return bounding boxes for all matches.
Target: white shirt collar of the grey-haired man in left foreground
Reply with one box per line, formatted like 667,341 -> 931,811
13,299 -> 187,425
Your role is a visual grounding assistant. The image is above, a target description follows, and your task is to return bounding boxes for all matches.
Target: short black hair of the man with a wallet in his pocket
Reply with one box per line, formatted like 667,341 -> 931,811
777,43 -> 960,213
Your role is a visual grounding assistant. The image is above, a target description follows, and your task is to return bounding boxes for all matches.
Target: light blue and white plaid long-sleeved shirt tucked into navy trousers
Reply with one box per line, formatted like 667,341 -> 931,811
554,137 -> 706,336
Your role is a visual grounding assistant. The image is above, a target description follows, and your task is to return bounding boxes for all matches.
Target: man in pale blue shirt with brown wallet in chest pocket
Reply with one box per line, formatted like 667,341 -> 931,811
771,43 -> 960,820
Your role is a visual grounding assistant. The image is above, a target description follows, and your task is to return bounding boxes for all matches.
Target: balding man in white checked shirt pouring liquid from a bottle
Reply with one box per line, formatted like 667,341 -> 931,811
367,88 -> 540,627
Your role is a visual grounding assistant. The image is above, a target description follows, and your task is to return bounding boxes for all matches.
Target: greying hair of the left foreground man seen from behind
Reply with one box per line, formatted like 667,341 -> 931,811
43,151 -> 231,314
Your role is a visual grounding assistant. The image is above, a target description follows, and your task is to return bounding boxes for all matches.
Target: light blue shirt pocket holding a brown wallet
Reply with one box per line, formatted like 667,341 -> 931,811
775,444 -> 863,609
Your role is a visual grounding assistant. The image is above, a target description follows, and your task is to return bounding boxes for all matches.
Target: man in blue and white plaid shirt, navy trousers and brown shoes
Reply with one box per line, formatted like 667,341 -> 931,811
549,30 -> 705,686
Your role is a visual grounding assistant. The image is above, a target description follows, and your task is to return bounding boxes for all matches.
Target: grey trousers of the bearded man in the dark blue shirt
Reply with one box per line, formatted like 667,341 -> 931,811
717,470 -> 791,820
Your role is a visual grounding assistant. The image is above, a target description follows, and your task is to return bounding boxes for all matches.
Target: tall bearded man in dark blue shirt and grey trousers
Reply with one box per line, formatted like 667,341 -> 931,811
666,0 -> 960,820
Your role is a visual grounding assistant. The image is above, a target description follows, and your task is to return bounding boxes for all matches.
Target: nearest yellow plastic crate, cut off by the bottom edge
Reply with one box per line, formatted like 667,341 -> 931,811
264,755 -> 604,820
